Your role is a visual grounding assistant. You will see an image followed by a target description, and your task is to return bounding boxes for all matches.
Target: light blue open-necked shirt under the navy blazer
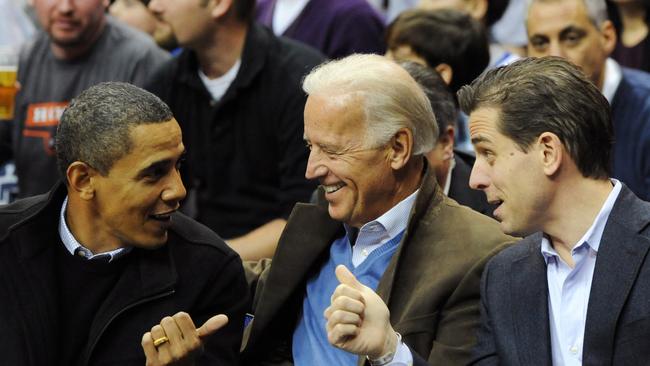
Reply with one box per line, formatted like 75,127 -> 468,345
541,179 -> 622,366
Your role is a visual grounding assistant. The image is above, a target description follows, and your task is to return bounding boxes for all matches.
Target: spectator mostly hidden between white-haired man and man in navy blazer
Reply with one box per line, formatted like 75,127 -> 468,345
399,61 -> 496,217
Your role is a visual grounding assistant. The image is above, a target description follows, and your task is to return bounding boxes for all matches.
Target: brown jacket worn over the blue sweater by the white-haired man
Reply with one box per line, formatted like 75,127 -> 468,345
243,167 -> 514,365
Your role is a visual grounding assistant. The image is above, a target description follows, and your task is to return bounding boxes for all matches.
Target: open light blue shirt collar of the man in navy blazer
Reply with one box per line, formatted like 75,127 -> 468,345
541,179 -> 622,264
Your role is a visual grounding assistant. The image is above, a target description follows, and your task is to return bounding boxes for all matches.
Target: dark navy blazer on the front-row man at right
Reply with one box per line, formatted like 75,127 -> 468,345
471,186 -> 650,365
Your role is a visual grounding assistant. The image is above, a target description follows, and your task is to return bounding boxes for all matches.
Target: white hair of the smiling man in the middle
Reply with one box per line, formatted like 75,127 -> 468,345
302,54 -> 438,155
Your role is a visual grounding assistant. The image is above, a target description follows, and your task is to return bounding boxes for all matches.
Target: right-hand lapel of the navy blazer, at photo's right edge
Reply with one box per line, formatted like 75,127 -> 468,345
583,187 -> 650,365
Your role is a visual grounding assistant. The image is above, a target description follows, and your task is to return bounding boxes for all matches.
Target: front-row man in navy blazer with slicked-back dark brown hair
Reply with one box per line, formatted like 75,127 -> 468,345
460,57 -> 650,365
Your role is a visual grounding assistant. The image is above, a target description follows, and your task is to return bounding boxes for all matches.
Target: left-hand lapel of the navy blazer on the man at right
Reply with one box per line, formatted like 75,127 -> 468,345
510,233 -> 551,365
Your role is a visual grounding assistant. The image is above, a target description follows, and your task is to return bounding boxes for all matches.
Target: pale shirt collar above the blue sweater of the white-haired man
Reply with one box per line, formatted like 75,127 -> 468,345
345,189 -> 420,267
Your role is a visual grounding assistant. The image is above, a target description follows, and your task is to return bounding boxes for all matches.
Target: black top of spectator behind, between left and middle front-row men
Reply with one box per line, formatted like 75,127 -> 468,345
147,24 -> 323,239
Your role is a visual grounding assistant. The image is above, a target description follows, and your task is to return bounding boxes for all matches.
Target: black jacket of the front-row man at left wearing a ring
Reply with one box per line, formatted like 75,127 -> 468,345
0,186 -> 248,366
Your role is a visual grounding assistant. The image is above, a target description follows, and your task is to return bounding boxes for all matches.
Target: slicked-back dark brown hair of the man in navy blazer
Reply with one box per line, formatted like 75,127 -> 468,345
458,57 -> 614,179
